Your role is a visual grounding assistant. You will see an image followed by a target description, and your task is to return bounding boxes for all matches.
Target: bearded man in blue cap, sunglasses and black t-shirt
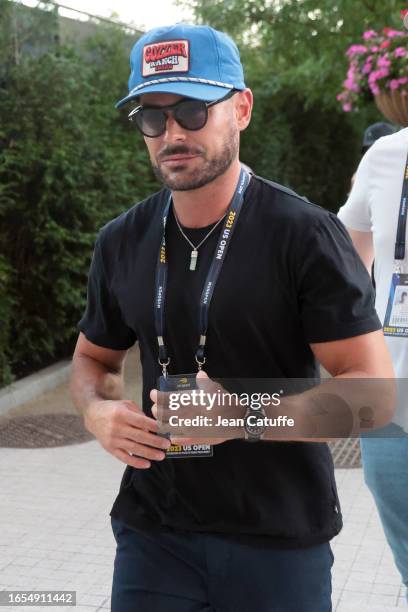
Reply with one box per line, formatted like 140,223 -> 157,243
72,25 -> 392,612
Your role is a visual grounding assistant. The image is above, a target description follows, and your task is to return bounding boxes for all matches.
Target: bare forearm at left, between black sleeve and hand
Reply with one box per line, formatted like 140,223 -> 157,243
70,355 -> 124,416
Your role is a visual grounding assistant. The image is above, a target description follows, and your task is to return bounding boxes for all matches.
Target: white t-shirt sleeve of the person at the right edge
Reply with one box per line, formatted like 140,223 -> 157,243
338,150 -> 371,232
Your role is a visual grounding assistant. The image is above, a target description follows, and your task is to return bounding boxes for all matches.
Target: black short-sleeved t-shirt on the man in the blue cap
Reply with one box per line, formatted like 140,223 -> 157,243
79,177 -> 381,547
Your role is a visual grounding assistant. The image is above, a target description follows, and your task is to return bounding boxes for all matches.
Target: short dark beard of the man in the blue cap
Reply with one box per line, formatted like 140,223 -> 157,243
152,129 -> 239,191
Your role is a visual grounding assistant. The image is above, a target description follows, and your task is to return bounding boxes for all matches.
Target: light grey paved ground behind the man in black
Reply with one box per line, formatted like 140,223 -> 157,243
0,354 -> 408,612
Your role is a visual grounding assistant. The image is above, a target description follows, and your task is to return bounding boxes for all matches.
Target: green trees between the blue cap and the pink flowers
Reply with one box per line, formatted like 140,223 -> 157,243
179,0 -> 405,211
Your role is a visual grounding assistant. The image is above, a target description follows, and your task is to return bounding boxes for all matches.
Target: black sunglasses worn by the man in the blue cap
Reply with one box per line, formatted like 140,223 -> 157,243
128,89 -> 237,138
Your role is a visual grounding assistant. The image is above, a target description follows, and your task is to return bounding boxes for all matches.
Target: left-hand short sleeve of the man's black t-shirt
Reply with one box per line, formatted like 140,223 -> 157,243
78,238 -> 137,350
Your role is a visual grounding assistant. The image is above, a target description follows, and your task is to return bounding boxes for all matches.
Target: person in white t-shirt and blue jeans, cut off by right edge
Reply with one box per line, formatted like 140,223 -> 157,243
339,128 -> 408,600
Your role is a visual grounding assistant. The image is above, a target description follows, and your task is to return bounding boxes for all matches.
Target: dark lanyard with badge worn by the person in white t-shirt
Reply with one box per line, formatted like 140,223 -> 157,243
384,155 -> 408,338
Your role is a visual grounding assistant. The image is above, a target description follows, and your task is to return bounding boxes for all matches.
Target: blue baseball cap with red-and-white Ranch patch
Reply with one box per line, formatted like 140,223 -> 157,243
116,23 -> 245,108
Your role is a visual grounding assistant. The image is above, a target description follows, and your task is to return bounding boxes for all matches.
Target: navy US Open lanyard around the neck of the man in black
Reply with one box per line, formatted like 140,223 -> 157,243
154,168 -> 250,376
